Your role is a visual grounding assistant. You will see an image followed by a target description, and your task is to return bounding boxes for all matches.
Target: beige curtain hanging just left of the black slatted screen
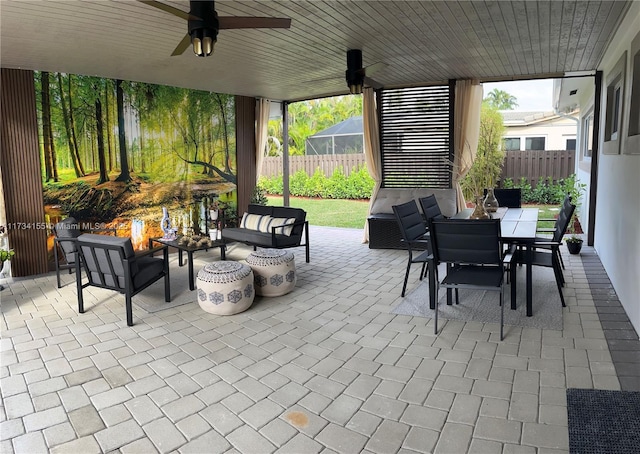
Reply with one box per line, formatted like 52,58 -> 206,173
362,87 -> 382,243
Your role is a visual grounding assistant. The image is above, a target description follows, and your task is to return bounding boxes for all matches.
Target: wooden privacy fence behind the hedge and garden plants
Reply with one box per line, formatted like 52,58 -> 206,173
261,150 -> 576,187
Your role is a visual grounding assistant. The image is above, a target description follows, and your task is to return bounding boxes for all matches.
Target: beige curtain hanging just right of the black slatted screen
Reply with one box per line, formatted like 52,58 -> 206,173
453,80 -> 483,210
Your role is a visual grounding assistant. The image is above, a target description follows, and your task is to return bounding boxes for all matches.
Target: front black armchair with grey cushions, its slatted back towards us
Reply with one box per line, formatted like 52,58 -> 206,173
75,233 -> 171,326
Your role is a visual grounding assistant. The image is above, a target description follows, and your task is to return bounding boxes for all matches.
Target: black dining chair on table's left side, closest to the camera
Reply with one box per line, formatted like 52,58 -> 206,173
392,200 -> 431,296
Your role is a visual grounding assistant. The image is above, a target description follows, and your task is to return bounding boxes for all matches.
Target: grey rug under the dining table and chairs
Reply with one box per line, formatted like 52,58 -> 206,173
392,265 -> 562,330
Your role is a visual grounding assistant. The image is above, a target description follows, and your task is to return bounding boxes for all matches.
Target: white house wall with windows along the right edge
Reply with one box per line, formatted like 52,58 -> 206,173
592,2 -> 640,332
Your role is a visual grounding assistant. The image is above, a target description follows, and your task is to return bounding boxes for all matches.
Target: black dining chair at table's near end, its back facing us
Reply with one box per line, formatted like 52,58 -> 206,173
429,219 -> 513,340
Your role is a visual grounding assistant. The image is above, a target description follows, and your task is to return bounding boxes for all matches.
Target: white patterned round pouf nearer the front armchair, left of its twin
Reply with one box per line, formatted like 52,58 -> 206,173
196,261 -> 256,315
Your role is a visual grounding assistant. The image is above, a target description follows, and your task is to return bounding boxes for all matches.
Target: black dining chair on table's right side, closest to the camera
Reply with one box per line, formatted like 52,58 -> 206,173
510,202 -> 576,307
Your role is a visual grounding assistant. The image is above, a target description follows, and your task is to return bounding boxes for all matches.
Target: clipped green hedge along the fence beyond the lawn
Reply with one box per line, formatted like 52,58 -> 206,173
258,166 -> 375,199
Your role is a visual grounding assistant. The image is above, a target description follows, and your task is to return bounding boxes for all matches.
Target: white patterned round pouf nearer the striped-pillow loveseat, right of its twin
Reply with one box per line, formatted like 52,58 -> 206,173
247,249 -> 296,296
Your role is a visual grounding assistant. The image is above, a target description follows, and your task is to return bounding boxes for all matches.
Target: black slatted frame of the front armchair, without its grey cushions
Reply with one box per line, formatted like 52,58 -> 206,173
75,234 -> 171,326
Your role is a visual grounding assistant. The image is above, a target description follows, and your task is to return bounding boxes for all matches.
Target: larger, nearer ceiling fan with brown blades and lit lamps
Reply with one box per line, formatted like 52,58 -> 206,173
138,0 -> 291,57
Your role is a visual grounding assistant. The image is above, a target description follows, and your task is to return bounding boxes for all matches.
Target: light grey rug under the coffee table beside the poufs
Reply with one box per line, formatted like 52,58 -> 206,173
132,254 -> 211,313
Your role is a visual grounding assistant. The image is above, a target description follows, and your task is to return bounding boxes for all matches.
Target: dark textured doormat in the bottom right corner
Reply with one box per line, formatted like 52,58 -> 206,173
567,388 -> 640,454
